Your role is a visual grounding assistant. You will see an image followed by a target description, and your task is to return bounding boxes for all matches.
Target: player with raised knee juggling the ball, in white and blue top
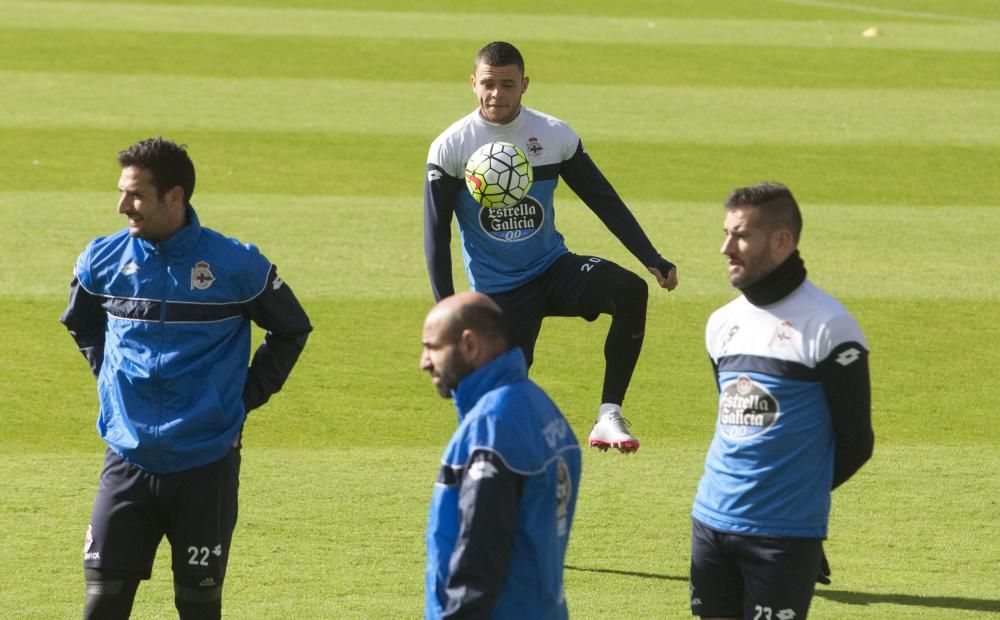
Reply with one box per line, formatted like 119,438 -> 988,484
424,41 -> 677,452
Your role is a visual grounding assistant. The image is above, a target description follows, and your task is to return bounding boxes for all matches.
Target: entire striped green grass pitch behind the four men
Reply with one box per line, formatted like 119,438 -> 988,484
0,0 -> 1000,618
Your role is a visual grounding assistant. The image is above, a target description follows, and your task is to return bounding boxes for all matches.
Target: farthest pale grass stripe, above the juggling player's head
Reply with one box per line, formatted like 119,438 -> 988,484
3,0 -> 1000,50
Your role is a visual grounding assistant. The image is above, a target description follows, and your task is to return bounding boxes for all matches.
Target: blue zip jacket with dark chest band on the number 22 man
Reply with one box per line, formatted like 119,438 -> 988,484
62,206 -> 312,473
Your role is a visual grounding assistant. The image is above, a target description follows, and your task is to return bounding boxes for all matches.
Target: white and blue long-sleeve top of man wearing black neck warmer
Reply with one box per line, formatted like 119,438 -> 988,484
692,274 -> 874,538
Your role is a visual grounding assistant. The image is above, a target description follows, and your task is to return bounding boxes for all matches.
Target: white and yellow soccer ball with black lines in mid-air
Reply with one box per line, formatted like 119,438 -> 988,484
465,142 -> 534,209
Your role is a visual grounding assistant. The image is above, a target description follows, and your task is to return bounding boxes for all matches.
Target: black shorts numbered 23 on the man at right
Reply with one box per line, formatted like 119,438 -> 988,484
691,520 -> 823,620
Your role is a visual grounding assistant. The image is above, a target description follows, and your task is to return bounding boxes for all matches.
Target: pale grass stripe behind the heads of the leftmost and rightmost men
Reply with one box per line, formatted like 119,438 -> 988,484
0,188 -> 1000,300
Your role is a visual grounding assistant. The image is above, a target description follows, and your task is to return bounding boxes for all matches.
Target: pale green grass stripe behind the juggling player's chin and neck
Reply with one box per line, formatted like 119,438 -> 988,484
0,71 -> 1000,145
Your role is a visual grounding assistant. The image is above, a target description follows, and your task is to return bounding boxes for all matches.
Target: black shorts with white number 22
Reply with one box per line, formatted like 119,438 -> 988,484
83,448 -> 240,584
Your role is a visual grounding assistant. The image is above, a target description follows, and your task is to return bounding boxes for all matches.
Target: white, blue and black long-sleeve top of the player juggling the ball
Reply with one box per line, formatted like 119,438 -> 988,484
424,106 -> 673,299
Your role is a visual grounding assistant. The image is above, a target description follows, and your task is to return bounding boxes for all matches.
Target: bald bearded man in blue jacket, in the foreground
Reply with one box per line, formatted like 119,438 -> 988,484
420,292 -> 580,619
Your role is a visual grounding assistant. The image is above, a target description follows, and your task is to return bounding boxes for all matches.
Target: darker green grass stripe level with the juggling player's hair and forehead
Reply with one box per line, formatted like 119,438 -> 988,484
0,28 -> 1000,90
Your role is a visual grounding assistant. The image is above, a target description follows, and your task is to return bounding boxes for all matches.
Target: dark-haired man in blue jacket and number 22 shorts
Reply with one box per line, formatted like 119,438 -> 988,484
62,138 -> 312,620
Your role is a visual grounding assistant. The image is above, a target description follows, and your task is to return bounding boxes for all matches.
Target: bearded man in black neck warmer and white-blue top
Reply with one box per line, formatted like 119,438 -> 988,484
691,183 -> 874,620
